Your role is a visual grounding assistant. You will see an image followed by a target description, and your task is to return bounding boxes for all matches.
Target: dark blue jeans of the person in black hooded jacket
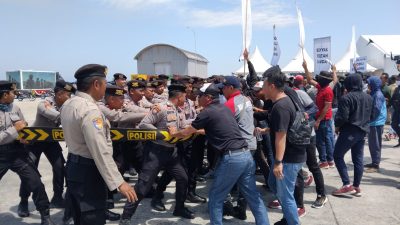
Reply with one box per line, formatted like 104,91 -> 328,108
333,130 -> 365,187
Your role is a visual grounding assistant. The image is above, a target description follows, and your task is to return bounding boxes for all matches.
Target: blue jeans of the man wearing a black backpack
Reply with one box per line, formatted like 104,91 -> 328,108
268,163 -> 303,225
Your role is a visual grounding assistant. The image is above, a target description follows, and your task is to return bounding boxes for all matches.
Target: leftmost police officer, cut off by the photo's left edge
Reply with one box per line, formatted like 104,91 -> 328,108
0,81 -> 51,225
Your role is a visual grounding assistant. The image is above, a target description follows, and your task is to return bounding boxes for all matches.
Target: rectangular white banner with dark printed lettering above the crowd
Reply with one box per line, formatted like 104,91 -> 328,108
314,37 -> 331,74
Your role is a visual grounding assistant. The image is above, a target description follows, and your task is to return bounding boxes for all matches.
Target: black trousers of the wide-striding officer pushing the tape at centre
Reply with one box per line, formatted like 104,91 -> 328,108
123,142 -> 188,216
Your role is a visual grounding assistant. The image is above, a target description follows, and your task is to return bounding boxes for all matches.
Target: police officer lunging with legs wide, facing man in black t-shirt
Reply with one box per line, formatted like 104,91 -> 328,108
120,85 -> 194,225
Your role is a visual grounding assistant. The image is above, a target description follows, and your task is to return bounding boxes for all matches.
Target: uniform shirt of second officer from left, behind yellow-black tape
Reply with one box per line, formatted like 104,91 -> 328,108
33,97 -> 60,127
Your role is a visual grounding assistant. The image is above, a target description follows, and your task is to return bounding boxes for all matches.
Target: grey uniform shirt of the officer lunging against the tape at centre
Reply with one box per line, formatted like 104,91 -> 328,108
139,101 -> 186,147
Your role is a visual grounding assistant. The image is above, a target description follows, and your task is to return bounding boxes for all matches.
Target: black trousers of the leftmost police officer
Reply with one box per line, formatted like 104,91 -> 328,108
0,145 -> 50,211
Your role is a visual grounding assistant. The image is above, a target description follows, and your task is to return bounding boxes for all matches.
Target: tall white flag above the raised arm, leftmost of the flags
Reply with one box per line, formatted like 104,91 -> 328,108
240,0 -> 252,59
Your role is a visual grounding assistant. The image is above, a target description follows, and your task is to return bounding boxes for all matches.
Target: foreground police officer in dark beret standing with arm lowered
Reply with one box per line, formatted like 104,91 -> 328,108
61,64 -> 137,225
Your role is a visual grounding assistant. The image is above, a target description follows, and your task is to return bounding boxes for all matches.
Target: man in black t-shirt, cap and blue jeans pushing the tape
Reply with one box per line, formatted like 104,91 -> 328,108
169,83 -> 269,225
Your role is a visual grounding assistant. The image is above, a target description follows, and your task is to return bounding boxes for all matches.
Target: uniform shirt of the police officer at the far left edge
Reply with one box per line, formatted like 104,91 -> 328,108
0,104 -> 25,145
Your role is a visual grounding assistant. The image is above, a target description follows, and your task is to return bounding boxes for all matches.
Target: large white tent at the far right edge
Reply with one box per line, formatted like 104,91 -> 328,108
357,35 -> 400,75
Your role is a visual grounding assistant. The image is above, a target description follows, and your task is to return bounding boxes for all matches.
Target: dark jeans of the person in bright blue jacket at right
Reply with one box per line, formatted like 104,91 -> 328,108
368,125 -> 383,166
